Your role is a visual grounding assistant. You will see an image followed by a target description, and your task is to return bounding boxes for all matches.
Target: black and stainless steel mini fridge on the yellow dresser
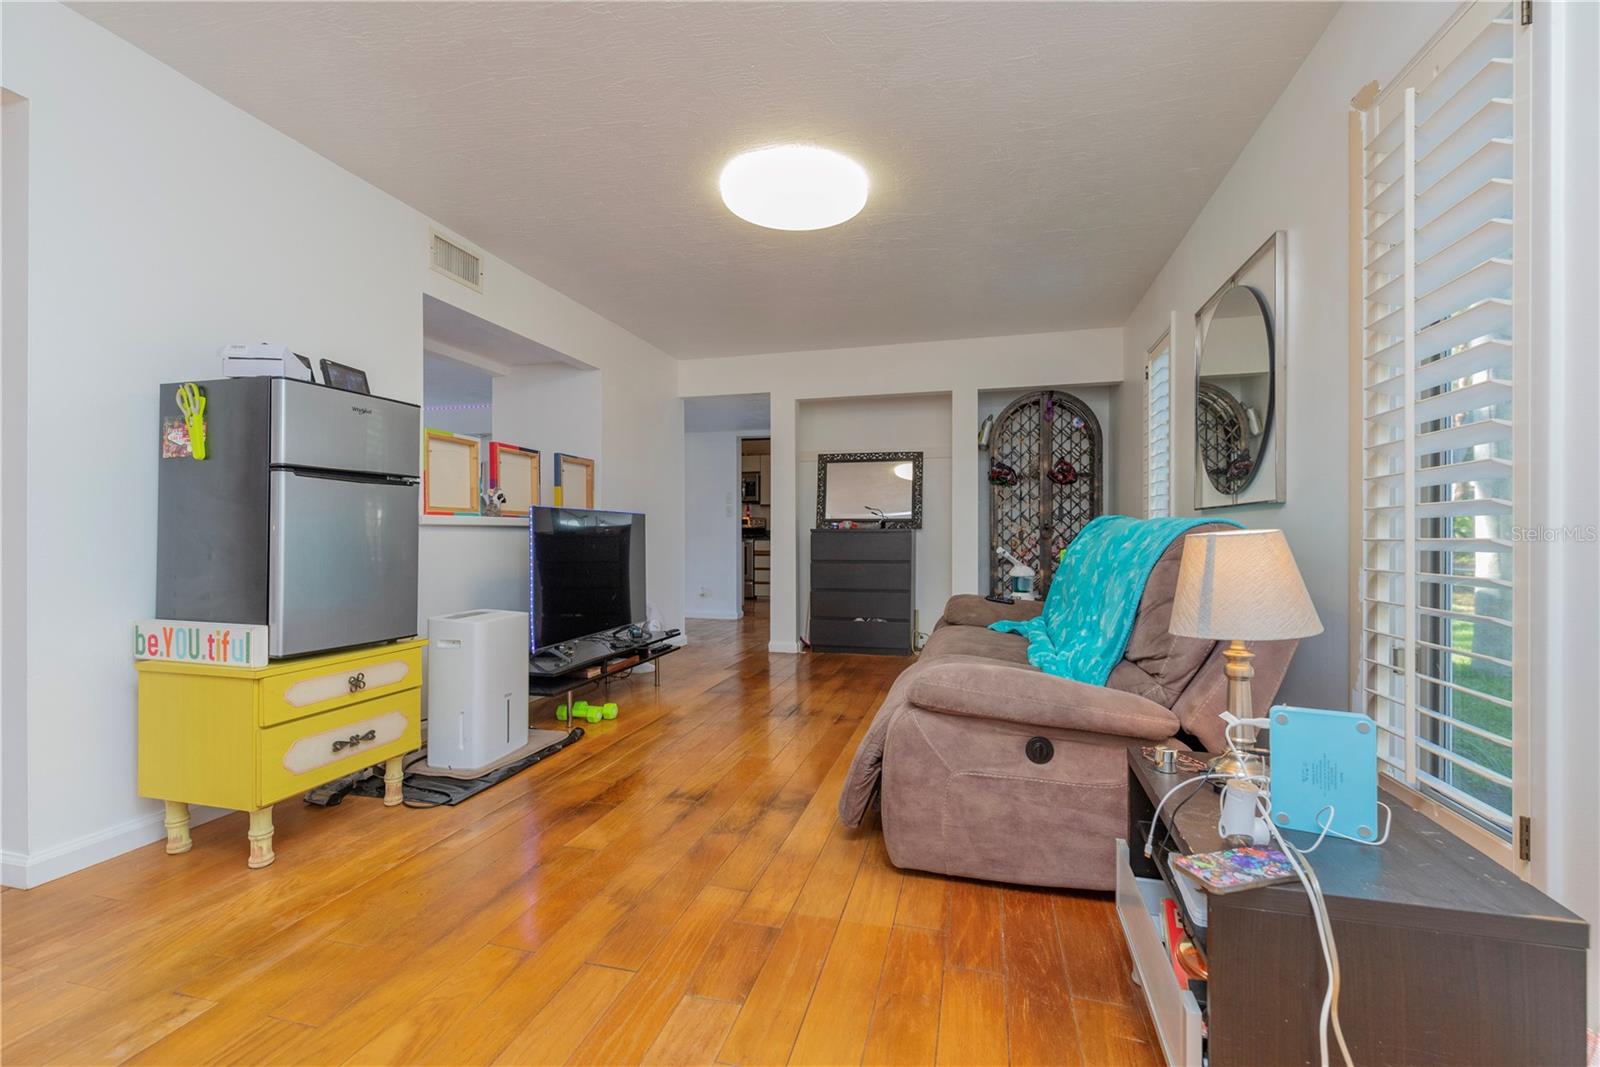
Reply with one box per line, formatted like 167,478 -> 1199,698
155,378 -> 421,657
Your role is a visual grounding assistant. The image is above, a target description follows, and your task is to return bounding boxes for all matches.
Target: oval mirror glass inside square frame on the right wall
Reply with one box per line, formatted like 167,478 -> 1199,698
1195,283 -> 1274,496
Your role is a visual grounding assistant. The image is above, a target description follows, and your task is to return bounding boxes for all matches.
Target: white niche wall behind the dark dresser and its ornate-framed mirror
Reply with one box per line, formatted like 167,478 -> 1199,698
796,394 -> 947,633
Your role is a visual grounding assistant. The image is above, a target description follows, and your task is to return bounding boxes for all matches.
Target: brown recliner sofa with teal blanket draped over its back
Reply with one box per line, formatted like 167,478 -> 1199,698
838,525 -> 1296,889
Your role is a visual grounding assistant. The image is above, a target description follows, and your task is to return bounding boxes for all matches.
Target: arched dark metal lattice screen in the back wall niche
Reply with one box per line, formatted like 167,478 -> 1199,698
989,389 -> 1104,597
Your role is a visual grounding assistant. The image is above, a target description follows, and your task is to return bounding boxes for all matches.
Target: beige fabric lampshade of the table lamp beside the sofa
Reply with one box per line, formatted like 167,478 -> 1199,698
1171,530 -> 1322,641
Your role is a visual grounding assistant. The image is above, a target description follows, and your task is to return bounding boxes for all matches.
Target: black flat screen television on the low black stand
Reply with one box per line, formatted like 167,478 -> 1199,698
528,507 -> 645,653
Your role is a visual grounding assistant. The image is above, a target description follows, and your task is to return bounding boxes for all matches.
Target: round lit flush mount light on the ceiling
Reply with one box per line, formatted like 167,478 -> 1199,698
717,144 -> 869,230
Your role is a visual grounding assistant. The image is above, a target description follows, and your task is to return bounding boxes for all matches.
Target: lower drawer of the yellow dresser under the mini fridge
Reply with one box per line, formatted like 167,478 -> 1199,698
258,688 -> 422,805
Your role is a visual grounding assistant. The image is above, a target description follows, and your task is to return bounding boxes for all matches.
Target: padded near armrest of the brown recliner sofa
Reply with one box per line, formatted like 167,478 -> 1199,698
906,662 -> 1178,741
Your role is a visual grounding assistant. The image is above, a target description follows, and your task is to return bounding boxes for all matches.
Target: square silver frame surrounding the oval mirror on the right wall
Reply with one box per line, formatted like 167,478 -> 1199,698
1187,230 -> 1290,512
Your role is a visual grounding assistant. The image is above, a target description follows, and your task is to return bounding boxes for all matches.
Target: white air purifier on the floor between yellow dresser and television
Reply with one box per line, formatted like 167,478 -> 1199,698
427,609 -> 528,771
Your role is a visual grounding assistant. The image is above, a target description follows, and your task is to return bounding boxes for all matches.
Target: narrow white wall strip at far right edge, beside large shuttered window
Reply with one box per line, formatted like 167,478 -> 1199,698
1528,3 -> 1600,1029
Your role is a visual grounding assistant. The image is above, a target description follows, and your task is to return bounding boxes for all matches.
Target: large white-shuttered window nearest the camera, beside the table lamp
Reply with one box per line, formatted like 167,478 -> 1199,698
1355,3 -> 1531,841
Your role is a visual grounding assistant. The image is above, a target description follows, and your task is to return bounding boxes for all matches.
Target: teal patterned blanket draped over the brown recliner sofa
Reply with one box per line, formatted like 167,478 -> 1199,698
989,515 -> 1238,685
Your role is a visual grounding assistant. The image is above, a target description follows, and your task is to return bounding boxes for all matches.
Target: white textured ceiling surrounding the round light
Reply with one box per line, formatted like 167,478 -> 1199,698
74,2 -> 1336,357
